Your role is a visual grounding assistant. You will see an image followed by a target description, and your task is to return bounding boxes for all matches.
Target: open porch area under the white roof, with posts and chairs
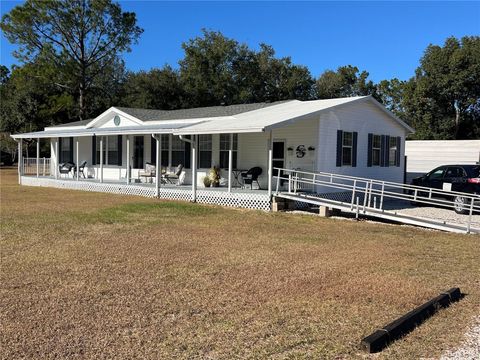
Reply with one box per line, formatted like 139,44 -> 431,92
18,130 -> 278,201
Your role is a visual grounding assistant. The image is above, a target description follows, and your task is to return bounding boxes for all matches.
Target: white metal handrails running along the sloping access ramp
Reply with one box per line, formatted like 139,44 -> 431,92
275,168 -> 480,233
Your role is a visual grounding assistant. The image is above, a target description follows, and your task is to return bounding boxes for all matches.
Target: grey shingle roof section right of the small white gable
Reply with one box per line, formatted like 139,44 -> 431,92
115,101 -> 285,121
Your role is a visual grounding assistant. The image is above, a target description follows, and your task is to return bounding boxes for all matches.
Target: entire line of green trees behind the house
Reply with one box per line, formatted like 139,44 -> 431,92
0,0 -> 480,143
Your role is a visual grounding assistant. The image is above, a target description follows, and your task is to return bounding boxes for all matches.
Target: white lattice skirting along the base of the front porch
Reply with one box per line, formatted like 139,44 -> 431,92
22,176 -> 270,211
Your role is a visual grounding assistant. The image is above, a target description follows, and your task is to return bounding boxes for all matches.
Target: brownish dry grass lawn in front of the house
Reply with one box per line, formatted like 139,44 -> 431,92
0,169 -> 480,359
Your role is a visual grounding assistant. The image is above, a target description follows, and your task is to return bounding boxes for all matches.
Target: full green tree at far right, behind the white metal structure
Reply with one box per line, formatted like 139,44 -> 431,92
403,36 -> 480,139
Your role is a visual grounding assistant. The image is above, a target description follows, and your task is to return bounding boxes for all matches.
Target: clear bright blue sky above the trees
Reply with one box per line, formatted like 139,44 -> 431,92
0,0 -> 480,81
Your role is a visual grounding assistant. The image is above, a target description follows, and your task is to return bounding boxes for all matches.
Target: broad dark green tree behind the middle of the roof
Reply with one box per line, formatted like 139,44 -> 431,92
180,30 -> 314,107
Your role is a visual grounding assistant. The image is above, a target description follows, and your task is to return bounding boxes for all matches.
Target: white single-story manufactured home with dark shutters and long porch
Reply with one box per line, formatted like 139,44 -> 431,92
12,96 -> 413,210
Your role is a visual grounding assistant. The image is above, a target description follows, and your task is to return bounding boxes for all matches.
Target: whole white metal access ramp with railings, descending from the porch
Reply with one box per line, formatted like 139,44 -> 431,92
274,168 -> 480,233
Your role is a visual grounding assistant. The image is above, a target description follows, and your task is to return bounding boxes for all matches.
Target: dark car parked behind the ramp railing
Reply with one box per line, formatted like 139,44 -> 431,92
412,165 -> 480,214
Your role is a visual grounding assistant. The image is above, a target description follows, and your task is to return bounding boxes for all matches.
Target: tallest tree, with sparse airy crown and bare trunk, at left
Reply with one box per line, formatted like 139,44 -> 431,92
0,0 -> 143,119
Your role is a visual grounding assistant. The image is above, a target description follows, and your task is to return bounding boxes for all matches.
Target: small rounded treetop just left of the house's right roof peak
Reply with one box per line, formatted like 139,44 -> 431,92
317,65 -> 376,99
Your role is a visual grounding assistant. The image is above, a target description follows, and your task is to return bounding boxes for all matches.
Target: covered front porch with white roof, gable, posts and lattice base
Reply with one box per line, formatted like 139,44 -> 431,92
12,104 -> 318,209
